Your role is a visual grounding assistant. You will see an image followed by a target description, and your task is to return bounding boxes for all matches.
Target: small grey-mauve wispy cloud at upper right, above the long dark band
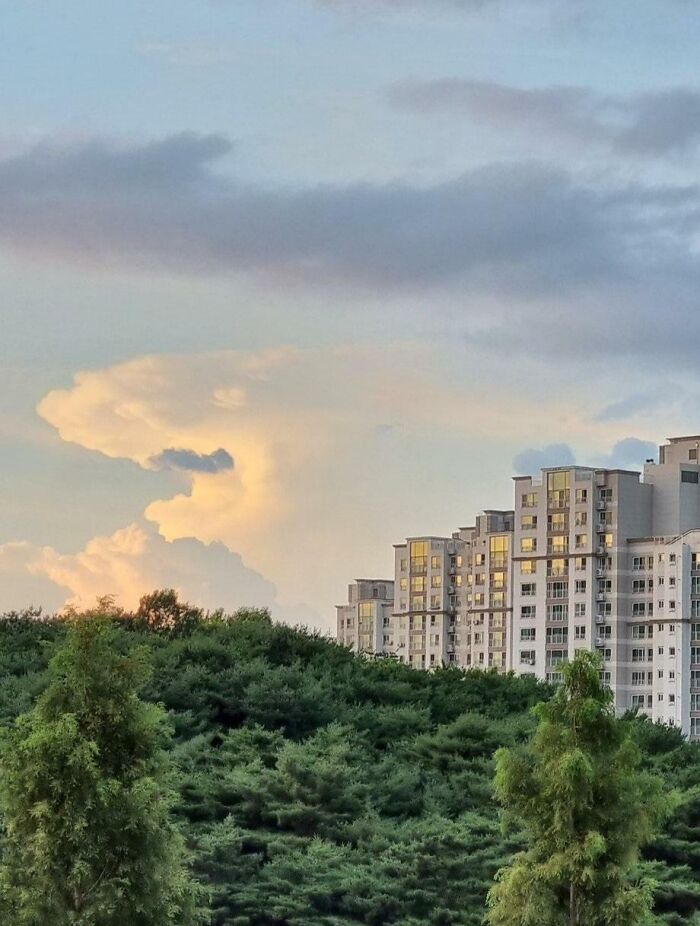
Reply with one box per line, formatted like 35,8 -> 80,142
389,78 -> 700,158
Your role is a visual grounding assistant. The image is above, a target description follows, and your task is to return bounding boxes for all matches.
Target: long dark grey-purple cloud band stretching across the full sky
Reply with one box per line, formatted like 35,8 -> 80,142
0,134 -> 700,303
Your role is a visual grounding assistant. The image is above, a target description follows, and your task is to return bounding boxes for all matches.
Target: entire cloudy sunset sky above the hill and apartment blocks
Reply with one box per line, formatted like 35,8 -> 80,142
0,0 -> 700,631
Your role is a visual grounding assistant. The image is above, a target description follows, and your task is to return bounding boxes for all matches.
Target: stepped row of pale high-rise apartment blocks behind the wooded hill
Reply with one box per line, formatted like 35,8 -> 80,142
338,436 -> 700,736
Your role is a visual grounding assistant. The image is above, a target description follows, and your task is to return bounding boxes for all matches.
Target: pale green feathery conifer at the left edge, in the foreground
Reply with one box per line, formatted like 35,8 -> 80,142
0,617 -> 202,926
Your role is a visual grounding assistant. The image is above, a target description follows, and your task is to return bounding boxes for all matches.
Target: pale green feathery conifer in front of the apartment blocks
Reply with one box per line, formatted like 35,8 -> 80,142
487,653 -> 672,926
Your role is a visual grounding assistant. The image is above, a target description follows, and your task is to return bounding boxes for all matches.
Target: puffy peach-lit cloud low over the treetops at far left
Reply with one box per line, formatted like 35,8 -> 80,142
0,524 -> 276,611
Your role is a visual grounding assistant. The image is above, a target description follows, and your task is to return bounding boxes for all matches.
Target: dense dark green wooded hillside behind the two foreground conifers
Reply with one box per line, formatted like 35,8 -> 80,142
0,592 -> 700,926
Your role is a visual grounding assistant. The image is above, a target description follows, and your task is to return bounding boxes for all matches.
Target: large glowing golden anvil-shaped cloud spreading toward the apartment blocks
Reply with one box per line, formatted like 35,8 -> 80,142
39,342 -> 592,619
